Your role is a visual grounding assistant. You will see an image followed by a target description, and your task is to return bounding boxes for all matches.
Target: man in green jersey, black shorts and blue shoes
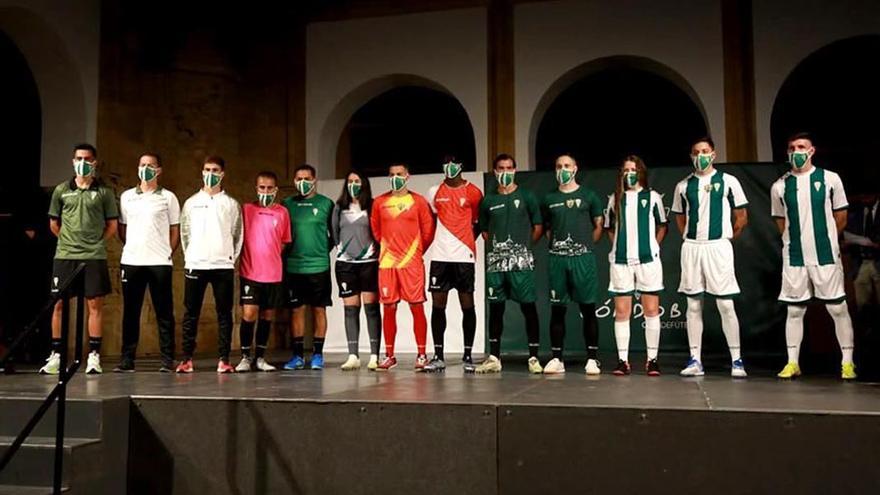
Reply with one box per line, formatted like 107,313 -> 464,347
283,164 -> 333,370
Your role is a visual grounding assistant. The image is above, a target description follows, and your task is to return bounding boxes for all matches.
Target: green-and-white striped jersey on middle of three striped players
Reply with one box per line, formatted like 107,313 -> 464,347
672,170 -> 749,241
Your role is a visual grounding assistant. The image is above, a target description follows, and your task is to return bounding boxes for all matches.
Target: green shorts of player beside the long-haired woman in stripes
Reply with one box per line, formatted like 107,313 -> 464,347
548,253 -> 599,304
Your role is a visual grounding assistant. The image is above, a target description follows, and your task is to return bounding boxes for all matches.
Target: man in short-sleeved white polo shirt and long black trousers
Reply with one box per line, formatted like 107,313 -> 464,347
113,153 -> 180,373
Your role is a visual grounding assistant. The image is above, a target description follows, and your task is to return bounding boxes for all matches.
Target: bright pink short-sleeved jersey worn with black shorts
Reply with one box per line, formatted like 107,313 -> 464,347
240,203 -> 291,283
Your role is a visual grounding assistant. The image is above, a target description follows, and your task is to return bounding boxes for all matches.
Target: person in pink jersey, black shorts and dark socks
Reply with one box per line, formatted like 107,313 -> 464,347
235,171 -> 291,372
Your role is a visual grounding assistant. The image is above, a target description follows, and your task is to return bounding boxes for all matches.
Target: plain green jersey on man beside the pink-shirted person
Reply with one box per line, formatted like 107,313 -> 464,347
282,194 -> 333,273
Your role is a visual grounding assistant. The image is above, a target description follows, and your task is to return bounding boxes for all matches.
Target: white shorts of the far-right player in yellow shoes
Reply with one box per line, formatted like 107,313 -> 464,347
779,259 -> 846,303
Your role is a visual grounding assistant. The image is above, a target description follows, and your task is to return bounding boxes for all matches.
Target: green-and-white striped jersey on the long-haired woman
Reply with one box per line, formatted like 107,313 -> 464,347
605,188 -> 666,265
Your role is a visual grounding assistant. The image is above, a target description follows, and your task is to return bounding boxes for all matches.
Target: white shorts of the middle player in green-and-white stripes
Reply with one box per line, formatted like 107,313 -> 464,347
678,239 -> 739,297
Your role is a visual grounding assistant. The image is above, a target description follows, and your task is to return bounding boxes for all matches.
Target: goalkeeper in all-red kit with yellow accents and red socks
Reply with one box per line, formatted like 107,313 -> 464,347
370,163 -> 434,371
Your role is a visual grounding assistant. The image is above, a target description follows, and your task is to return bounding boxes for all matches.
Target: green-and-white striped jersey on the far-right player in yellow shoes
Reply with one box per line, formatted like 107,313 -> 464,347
770,167 -> 849,266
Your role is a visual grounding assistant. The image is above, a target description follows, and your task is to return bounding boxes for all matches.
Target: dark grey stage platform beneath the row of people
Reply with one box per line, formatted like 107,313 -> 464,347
0,356 -> 880,494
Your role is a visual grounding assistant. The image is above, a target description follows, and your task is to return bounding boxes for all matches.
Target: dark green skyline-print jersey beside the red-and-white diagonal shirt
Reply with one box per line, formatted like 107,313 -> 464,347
480,186 -> 541,272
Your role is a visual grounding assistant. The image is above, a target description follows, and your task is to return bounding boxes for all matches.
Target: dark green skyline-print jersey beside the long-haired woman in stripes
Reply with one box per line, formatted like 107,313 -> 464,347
542,186 -> 604,256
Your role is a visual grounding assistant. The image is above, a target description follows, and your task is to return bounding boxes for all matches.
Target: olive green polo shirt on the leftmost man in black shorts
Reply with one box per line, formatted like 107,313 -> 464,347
49,179 -> 119,260
